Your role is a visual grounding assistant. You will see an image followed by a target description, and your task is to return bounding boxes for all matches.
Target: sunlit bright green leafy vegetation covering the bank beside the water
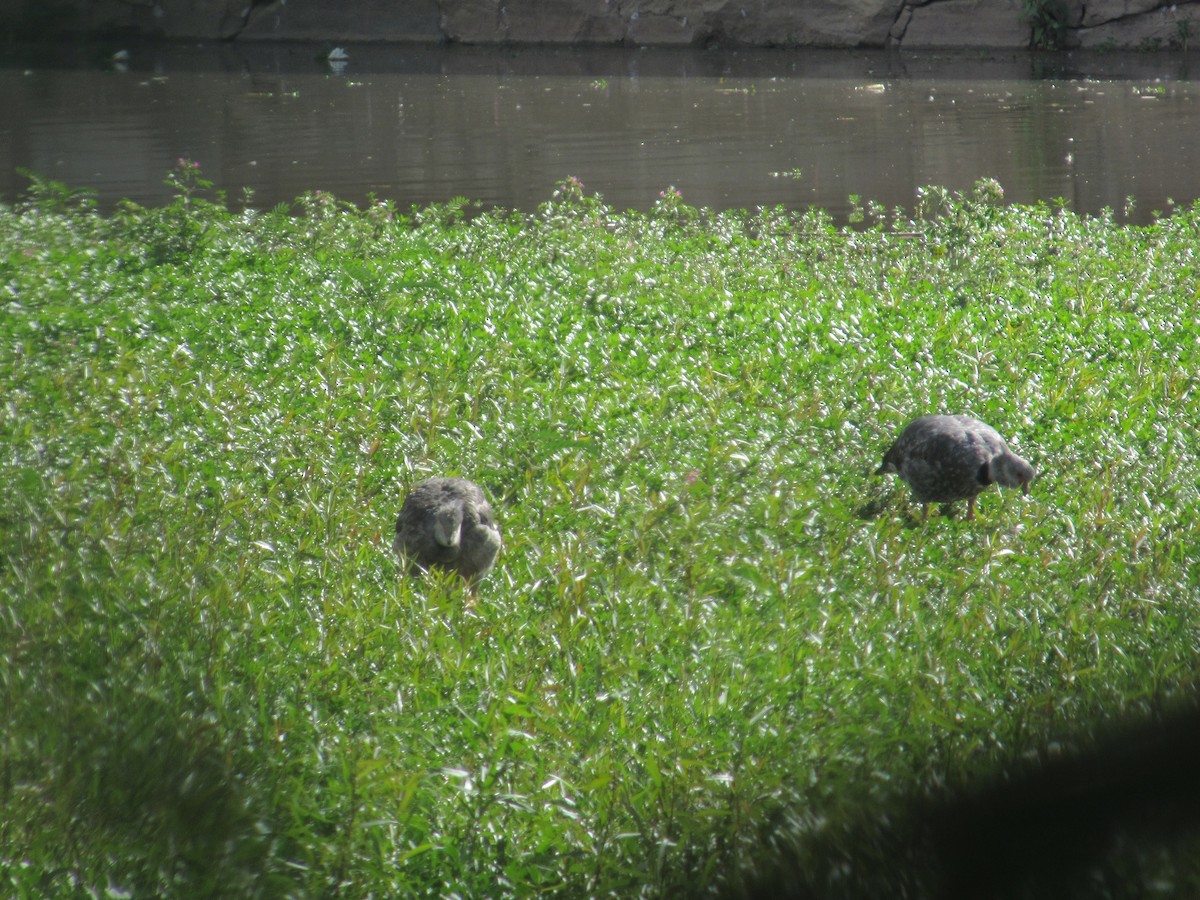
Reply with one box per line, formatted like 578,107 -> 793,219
0,163 -> 1200,898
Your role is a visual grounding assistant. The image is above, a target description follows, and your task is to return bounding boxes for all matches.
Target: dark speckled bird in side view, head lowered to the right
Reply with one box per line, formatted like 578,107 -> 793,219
875,415 -> 1033,522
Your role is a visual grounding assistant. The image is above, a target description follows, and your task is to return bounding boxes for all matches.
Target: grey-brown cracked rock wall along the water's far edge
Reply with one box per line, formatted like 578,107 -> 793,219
7,0 -> 1200,49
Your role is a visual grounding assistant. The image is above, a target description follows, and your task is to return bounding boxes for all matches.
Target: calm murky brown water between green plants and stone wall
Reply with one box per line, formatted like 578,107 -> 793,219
0,44 -> 1200,221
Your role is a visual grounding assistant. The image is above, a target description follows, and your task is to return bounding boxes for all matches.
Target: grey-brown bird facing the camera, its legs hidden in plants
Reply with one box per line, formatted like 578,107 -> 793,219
392,478 -> 500,588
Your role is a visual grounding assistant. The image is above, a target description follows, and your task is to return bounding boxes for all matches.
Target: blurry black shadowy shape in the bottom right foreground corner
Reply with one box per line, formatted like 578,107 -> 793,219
725,708 -> 1200,900
